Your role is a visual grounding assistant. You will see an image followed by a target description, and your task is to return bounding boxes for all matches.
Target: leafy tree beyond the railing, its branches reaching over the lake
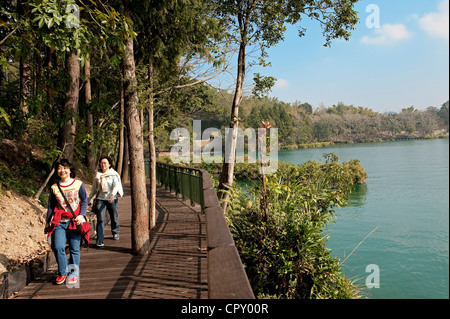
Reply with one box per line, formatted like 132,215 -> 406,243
214,0 -> 358,211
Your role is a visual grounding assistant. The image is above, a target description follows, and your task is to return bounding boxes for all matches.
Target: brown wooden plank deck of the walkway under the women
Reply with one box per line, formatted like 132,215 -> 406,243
14,187 -> 208,299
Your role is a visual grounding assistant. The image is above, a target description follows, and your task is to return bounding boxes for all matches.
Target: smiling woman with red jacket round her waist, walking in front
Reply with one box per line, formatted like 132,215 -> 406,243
46,159 -> 88,285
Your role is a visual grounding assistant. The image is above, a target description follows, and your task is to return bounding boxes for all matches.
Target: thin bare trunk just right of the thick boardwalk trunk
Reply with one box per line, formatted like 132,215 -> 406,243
148,60 -> 156,229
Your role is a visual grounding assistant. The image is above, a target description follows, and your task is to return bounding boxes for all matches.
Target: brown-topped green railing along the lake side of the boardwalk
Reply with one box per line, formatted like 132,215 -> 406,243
156,162 -> 255,299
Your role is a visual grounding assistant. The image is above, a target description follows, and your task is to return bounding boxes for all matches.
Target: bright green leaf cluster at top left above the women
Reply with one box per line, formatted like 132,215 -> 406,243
22,0 -> 135,66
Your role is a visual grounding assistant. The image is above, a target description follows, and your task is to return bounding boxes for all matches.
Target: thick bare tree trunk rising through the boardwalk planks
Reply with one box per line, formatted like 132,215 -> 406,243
122,37 -> 150,255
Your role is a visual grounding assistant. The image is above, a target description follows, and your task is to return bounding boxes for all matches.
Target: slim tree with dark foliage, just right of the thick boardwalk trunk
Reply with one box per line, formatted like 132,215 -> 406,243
129,0 -> 229,228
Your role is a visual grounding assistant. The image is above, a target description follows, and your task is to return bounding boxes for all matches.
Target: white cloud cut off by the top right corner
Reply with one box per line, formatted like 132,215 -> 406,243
419,0 -> 449,39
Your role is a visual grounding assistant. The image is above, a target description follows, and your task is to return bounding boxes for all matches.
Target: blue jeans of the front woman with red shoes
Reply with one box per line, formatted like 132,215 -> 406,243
52,222 -> 81,278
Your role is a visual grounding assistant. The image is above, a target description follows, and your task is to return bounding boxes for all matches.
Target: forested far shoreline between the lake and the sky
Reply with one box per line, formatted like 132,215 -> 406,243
161,91 -> 449,149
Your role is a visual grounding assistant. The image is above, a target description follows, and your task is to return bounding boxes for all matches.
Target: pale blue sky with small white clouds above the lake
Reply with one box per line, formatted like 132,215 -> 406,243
251,0 -> 449,113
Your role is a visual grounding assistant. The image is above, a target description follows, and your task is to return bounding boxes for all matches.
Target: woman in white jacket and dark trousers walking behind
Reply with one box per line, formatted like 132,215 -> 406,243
88,156 -> 123,247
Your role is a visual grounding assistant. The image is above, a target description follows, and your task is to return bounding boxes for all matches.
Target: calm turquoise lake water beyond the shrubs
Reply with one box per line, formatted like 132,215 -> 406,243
279,139 -> 449,299
